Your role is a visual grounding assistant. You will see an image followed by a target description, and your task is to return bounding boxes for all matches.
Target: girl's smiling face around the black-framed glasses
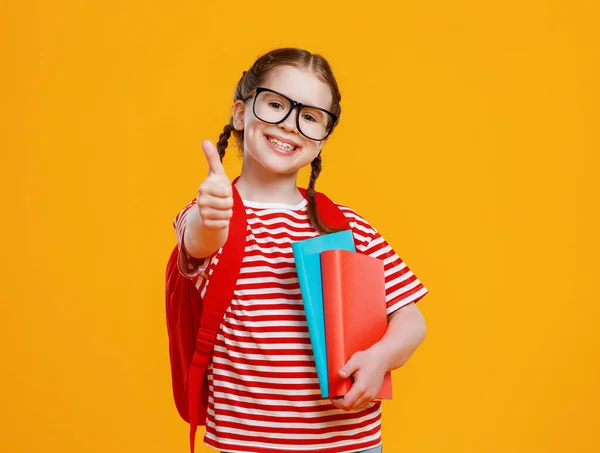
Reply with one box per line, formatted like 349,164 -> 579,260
233,66 -> 332,174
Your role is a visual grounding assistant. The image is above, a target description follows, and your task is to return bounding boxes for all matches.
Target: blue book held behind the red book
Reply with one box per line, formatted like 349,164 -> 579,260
292,230 -> 356,398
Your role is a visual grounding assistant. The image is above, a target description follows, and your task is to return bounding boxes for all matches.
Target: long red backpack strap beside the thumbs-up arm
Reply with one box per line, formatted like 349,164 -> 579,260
188,184 -> 247,453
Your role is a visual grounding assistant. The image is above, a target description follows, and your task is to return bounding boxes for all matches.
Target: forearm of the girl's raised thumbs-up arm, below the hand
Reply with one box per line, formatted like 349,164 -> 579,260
183,205 -> 229,258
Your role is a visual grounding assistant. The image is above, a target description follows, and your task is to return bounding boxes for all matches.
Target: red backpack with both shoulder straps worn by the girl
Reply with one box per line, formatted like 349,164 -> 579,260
165,185 -> 350,453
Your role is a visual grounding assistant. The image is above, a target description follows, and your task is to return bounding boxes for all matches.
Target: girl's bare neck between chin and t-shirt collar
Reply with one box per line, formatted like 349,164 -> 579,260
235,162 -> 303,205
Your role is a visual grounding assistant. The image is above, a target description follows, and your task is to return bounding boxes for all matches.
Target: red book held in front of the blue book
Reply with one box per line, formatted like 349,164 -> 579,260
321,250 -> 392,399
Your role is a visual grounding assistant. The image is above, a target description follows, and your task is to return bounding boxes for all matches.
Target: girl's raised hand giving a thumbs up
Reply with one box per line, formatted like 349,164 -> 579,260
196,140 -> 233,230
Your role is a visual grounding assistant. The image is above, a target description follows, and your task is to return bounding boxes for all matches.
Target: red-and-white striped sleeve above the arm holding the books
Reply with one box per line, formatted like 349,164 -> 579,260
338,205 -> 428,315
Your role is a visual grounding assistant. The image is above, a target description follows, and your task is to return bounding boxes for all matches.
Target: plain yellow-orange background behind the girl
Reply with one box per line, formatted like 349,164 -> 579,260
0,0 -> 600,453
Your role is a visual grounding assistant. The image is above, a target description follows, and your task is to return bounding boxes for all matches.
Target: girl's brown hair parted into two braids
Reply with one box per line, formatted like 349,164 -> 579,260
217,48 -> 342,234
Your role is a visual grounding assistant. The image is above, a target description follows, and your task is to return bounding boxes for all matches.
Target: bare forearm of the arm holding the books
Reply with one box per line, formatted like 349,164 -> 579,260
373,303 -> 426,371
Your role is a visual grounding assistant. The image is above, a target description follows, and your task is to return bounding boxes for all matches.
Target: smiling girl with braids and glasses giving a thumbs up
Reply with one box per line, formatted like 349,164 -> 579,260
174,48 -> 427,453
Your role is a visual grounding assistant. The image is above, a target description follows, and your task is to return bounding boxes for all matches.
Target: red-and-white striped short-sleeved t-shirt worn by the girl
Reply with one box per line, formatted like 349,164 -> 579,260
174,195 -> 427,453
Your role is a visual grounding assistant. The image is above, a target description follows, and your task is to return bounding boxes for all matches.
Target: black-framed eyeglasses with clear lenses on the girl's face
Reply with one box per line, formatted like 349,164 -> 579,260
244,87 -> 337,141
